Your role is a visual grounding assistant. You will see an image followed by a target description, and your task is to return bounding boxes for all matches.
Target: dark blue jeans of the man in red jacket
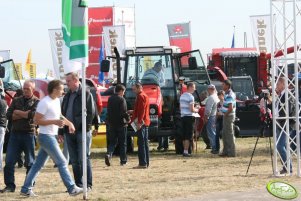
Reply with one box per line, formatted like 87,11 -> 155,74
137,126 -> 149,166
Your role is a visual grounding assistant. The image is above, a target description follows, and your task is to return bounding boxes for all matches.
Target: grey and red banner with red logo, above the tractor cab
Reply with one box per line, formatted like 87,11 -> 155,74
167,22 -> 191,52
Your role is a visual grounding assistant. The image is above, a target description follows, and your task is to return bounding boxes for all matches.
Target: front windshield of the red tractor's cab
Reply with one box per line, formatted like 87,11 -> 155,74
126,55 -> 174,88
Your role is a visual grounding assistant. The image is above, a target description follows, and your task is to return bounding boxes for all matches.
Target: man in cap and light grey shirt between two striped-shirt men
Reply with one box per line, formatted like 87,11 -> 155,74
204,84 -> 219,154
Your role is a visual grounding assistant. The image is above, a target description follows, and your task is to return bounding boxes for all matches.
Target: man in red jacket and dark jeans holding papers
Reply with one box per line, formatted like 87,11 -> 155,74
129,83 -> 150,169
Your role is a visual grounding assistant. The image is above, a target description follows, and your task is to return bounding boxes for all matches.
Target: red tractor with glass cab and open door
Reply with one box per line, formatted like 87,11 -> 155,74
101,46 -> 210,153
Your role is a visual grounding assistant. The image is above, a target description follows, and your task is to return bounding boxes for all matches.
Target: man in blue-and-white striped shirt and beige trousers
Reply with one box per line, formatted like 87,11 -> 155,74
220,80 -> 236,157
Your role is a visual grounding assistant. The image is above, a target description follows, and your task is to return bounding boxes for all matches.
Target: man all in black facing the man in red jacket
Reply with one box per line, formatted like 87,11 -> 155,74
105,84 -> 130,166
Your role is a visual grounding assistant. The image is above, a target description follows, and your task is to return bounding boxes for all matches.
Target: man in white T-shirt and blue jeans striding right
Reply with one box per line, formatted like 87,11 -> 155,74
20,80 -> 83,197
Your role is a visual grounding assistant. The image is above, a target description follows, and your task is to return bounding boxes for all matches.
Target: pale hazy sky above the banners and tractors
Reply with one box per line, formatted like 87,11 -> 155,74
0,0 -> 270,74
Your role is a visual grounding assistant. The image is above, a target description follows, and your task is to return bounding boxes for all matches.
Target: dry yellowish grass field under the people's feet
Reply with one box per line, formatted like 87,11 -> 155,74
0,138 -> 300,201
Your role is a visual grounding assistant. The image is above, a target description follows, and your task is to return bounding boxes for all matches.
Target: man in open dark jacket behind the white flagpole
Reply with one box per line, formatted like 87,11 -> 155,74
62,73 -> 98,190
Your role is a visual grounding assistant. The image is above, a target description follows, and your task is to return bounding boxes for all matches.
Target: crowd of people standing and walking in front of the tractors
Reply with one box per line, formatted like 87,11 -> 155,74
0,69 -> 292,197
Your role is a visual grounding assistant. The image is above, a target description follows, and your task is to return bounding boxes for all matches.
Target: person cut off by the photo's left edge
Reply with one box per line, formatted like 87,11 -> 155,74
0,87 -> 7,170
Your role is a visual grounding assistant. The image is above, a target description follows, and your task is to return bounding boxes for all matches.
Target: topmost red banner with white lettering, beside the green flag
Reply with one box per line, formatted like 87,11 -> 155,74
88,7 -> 113,35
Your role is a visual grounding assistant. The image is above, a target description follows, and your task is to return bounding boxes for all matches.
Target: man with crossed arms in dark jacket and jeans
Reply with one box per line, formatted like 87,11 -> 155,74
0,80 -> 39,193
